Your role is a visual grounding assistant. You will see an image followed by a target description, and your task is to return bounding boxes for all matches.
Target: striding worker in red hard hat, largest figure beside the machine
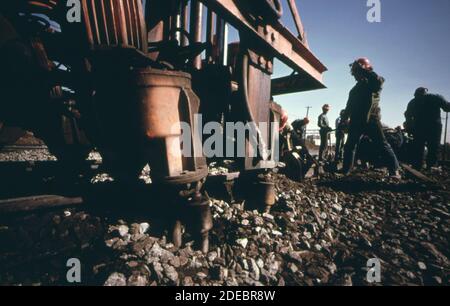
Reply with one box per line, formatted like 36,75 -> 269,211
342,58 -> 400,179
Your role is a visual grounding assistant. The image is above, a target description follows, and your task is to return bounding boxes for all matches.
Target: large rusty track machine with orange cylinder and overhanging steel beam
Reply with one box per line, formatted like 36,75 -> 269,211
0,0 -> 326,251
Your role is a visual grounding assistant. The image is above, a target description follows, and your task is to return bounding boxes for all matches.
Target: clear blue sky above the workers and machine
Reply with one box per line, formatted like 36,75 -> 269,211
274,0 -> 450,141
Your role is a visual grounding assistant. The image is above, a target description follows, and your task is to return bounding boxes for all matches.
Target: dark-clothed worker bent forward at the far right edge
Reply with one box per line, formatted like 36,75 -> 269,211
405,87 -> 450,171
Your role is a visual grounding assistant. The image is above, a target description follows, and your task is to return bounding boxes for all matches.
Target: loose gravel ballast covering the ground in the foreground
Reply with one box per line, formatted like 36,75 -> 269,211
0,147 -> 450,285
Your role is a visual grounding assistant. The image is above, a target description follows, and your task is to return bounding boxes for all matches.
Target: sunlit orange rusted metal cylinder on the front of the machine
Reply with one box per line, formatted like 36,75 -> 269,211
131,69 -> 207,184
